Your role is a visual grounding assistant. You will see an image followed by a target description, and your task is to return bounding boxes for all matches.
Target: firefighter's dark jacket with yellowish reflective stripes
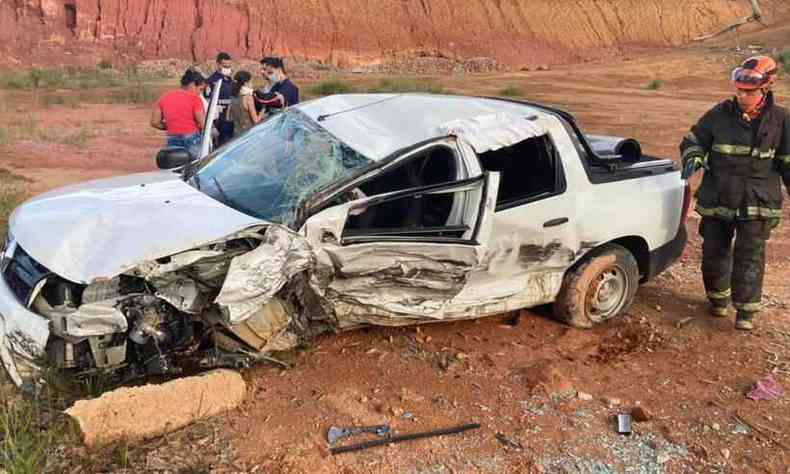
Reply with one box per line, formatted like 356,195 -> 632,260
680,92 -> 790,220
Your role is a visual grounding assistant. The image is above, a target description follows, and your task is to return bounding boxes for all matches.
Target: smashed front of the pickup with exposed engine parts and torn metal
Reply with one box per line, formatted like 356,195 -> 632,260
20,228 -> 320,386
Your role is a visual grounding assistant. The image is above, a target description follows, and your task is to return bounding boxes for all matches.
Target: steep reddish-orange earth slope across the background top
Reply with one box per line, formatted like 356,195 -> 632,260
0,0 -> 790,66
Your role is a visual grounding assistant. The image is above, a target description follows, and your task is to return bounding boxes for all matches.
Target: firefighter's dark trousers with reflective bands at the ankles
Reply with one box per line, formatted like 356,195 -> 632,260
699,217 -> 774,313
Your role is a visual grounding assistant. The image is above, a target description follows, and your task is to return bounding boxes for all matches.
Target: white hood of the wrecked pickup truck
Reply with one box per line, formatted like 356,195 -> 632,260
9,171 -> 266,283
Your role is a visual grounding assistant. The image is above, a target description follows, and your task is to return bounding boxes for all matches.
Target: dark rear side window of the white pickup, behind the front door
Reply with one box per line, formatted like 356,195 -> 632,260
478,135 -> 565,211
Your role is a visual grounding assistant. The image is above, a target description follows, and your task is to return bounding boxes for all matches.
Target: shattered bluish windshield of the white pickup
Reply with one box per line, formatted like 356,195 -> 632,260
189,109 -> 372,225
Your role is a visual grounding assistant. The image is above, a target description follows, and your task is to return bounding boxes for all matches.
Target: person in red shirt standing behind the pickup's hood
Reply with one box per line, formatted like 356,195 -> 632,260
151,69 -> 206,159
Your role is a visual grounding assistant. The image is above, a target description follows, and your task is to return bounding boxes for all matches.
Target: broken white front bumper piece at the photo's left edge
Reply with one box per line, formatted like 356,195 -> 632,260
0,268 -> 49,389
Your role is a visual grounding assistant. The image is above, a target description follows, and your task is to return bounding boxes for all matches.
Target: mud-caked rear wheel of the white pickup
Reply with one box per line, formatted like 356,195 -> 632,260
554,244 -> 639,328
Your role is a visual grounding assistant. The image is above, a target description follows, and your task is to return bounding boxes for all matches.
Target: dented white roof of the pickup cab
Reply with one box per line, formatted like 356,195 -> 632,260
296,94 -> 547,161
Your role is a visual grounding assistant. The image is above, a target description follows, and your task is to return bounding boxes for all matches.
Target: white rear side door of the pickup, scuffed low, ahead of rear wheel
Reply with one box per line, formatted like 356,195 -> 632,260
448,119 -> 584,316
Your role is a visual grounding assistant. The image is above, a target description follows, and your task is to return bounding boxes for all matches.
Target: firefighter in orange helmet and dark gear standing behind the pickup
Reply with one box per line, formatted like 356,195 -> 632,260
680,56 -> 790,330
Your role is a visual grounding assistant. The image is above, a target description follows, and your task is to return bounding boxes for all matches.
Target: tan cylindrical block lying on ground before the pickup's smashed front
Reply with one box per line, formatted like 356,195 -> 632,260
66,370 -> 247,448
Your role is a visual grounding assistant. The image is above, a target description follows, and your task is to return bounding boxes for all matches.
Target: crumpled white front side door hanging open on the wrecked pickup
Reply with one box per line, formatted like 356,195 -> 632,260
304,173 -> 499,328
